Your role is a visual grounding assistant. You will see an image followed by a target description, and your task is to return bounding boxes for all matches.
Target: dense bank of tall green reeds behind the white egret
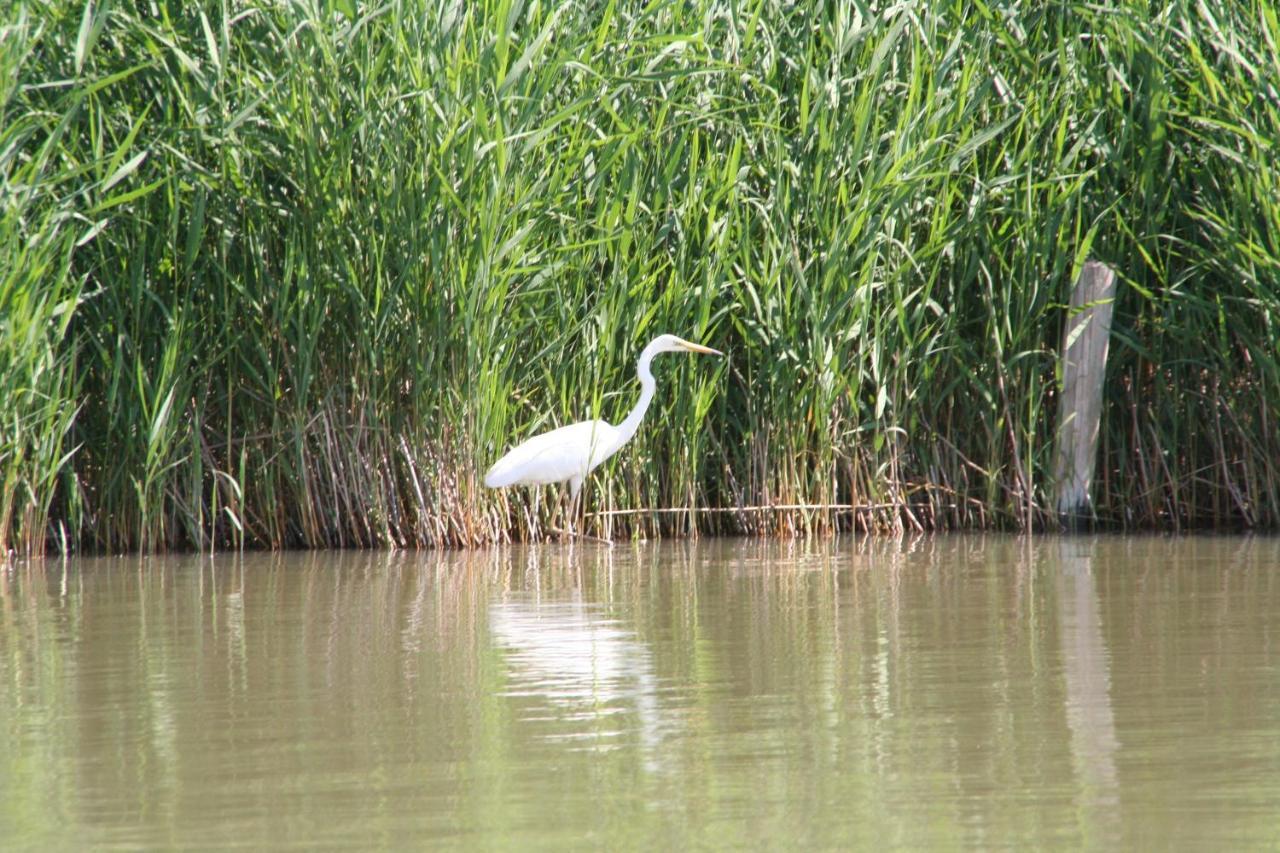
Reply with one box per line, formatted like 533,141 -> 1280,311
0,0 -> 1280,553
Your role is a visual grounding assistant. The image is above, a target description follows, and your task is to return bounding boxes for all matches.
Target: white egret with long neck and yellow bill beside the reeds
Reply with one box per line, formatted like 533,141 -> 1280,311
484,334 -> 723,525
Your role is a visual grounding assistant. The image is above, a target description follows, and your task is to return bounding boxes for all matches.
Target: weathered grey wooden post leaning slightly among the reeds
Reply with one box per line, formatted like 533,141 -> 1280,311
1053,261 -> 1116,529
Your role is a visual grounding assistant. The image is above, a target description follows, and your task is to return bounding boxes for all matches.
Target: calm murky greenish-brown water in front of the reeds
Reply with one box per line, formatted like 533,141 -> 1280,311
0,537 -> 1280,849
